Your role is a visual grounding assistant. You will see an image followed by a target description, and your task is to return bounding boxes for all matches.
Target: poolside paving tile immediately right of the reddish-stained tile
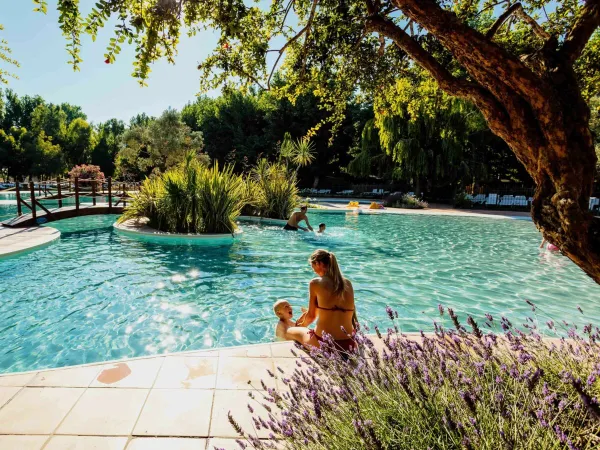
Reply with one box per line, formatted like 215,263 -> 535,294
154,356 -> 219,389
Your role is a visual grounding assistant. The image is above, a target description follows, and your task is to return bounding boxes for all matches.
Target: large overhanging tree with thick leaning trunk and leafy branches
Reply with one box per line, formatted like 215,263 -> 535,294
49,0 -> 600,282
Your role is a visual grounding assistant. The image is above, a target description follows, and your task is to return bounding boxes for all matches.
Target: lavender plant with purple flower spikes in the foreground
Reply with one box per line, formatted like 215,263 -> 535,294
230,302 -> 600,450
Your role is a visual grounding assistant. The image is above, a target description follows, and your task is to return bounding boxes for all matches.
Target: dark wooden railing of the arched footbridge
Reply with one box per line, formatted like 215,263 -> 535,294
11,177 -> 139,219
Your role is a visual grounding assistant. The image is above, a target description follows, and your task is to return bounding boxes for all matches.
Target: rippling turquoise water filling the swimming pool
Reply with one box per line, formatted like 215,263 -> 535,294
0,213 -> 600,372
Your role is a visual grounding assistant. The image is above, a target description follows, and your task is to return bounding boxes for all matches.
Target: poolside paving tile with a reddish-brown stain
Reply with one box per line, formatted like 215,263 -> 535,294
91,357 -> 164,389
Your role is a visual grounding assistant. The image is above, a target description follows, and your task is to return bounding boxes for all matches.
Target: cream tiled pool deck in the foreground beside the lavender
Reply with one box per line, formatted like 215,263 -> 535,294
0,341 -> 318,450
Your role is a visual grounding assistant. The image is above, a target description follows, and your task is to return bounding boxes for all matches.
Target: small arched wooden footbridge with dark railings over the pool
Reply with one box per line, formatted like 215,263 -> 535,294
2,177 -> 139,228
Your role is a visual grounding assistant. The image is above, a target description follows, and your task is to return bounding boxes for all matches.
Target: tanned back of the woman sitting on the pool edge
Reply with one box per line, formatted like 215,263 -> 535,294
311,276 -> 355,339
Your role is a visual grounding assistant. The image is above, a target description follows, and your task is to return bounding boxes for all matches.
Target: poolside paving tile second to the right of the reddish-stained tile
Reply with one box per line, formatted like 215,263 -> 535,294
217,357 -> 275,389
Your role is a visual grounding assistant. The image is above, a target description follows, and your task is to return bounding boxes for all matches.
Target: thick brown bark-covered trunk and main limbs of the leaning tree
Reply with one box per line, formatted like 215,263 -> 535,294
366,0 -> 600,283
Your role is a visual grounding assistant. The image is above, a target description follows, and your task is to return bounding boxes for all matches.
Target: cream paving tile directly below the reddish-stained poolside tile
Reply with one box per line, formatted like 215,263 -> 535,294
56,389 -> 148,436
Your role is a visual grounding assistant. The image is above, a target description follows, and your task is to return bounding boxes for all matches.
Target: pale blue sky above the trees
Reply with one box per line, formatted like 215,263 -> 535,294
0,0 -> 219,123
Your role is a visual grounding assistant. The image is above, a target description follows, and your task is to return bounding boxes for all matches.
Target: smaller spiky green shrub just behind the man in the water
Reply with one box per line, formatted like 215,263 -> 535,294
247,159 -> 298,219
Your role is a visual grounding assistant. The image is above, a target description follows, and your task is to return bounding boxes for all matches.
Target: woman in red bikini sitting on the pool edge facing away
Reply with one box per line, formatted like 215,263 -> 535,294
286,250 -> 356,351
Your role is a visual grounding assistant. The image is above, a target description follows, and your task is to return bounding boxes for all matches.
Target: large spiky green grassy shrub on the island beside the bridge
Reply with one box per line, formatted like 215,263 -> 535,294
119,153 -> 245,233
